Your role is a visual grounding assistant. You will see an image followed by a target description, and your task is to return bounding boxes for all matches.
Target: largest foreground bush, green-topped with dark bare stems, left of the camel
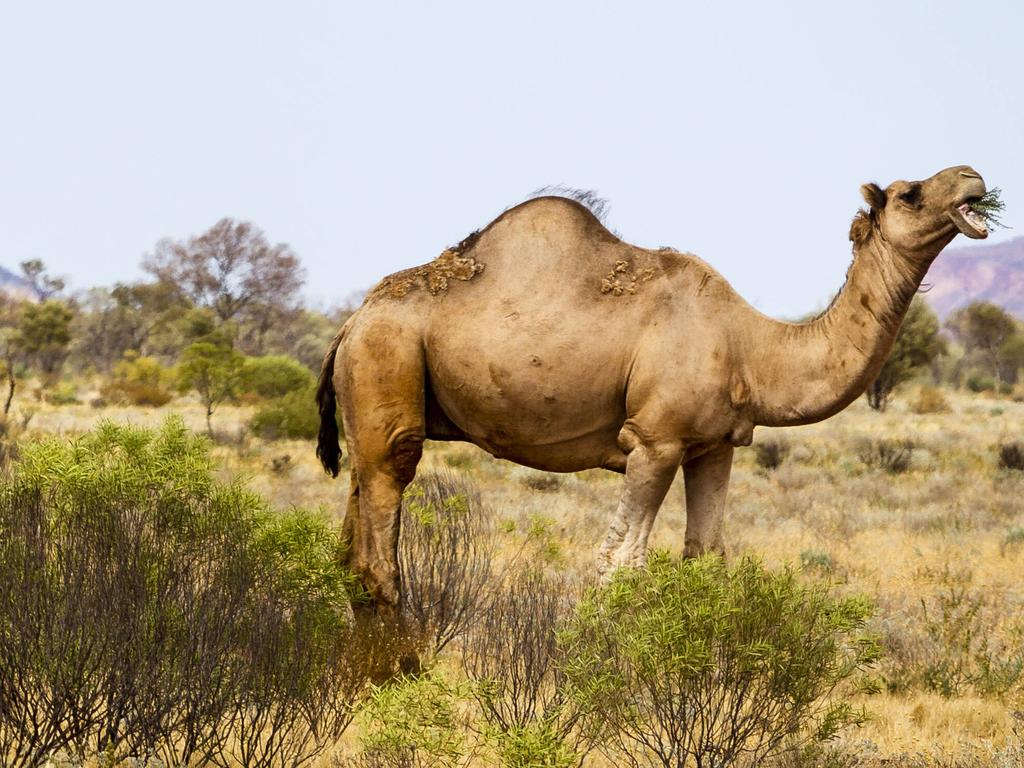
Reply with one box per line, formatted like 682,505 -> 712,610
0,419 -> 366,766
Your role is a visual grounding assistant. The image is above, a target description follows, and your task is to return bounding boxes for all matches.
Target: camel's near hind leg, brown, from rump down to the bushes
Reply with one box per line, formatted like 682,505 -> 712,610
336,322 -> 425,612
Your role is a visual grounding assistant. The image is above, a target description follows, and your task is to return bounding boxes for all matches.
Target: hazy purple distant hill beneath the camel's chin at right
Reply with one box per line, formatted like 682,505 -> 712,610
925,238 -> 1024,318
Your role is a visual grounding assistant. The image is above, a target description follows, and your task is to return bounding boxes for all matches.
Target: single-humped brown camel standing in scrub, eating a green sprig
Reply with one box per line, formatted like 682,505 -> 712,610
316,166 -> 987,611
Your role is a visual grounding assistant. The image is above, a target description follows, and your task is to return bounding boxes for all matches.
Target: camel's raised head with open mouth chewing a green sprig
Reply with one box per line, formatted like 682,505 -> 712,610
850,165 -> 988,257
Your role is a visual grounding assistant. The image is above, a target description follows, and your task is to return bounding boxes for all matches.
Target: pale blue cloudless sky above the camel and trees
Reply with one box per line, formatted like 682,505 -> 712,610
0,0 -> 1024,316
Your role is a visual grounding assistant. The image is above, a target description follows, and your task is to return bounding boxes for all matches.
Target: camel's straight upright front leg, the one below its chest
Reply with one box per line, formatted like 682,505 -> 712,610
683,445 -> 732,557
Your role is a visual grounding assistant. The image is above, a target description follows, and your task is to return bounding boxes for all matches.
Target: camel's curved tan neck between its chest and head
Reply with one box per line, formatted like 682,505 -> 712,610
745,231 -> 944,426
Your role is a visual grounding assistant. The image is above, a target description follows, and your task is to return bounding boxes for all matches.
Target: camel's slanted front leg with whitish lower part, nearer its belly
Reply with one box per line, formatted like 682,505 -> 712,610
597,442 -> 683,577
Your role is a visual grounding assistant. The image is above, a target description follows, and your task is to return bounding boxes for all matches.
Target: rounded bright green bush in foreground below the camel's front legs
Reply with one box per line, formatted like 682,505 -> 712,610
561,553 -> 878,768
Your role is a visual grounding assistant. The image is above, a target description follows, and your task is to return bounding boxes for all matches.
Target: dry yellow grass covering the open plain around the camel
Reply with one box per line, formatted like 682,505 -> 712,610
9,385 -> 1024,765
